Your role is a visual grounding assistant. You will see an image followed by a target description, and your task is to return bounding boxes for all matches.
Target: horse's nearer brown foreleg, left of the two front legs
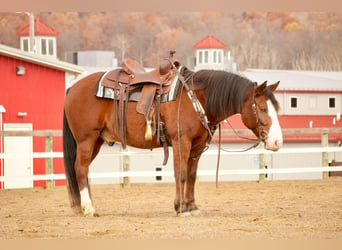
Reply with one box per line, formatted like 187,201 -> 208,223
172,140 -> 191,214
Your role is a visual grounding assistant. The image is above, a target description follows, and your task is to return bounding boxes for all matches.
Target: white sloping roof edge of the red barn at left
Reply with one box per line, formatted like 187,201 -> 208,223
0,44 -> 84,74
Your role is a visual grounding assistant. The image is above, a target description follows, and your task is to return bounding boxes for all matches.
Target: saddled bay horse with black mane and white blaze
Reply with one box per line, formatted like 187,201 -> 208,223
63,61 -> 282,216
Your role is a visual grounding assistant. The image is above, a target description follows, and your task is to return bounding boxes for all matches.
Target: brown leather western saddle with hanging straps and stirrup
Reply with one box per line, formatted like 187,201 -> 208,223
101,51 -> 180,165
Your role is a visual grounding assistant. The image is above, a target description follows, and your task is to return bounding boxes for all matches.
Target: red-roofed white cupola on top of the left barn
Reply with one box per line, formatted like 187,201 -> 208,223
17,18 -> 59,57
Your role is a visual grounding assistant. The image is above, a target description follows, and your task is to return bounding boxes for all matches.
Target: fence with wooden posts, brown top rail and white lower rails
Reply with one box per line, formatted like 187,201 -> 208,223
0,128 -> 342,187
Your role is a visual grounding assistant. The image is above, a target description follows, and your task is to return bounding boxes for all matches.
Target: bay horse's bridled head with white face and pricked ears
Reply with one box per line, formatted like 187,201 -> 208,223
241,82 -> 283,151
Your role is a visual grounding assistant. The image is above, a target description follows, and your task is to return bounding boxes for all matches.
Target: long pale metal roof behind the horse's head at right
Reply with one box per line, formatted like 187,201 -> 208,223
240,69 -> 342,92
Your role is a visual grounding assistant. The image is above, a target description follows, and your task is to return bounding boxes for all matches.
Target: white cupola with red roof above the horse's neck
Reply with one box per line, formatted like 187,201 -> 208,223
194,34 -> 227,71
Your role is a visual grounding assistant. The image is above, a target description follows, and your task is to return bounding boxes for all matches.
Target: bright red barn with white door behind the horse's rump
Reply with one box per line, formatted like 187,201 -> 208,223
0,45 -> 83,188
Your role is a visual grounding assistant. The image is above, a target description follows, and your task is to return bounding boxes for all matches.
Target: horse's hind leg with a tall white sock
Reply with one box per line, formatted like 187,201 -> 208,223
75,137 -> 100,216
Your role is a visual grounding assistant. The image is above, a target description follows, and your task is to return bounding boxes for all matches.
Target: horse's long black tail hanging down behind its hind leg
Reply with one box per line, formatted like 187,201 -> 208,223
63,105 -> 81,207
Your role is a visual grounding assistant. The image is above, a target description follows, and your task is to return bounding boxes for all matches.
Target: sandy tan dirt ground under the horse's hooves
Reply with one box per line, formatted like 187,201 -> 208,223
0,177 -> 342,239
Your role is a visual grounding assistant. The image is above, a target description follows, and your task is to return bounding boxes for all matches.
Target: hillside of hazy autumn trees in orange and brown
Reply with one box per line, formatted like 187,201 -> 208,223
0,11 -> 342,70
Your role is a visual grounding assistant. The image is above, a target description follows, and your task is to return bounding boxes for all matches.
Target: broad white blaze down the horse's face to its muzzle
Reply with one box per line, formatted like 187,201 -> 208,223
266,100 -> 283,150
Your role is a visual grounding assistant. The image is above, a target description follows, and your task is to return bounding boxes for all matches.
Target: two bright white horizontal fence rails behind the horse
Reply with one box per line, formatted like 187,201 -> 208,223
0,147 -> 342,182
